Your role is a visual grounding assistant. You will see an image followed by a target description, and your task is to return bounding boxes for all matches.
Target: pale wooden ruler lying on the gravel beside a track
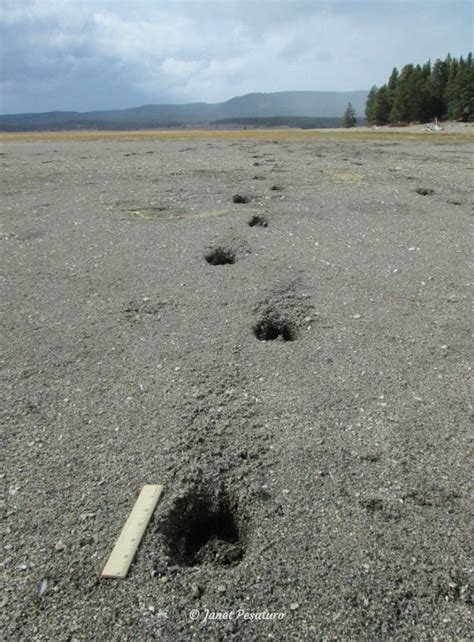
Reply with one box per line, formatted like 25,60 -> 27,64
101,484 -> 163,579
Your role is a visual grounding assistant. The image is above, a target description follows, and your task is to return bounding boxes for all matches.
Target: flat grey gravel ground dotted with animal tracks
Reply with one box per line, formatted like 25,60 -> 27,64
0,134 -> 474,642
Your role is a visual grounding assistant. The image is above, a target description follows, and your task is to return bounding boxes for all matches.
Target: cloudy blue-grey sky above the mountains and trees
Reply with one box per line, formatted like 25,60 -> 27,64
0,0 -> 474,114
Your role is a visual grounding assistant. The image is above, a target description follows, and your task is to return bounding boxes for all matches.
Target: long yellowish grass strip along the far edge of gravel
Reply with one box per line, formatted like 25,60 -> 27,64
0,128 -> 474,143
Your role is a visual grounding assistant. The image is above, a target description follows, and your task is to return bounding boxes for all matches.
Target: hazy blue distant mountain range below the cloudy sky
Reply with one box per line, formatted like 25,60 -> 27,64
0,91 -> 368,131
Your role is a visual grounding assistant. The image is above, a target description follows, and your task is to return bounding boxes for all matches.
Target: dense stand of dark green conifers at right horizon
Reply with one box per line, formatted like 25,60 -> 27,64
365,52 -> 474,125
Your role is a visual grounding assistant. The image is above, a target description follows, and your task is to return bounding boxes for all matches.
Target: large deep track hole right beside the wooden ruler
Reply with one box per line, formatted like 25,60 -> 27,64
162,490 -> 245,567
